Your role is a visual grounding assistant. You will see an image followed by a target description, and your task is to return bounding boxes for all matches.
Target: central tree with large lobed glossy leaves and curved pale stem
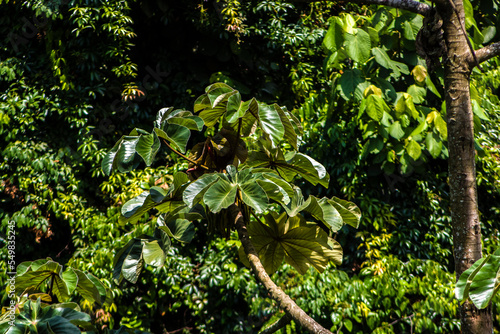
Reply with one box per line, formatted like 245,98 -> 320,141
102,83 -> 361,333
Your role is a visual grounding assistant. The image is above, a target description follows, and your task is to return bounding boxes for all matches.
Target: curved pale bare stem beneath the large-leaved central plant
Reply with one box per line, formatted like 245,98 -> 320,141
230,205 -> 332,334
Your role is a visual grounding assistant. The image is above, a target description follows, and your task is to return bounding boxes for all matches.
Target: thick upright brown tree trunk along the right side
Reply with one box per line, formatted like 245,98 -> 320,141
438,0 -> 493,334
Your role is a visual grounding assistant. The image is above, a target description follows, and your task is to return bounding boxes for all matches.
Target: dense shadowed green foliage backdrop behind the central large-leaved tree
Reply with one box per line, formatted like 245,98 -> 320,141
0,0 -> 500,333
